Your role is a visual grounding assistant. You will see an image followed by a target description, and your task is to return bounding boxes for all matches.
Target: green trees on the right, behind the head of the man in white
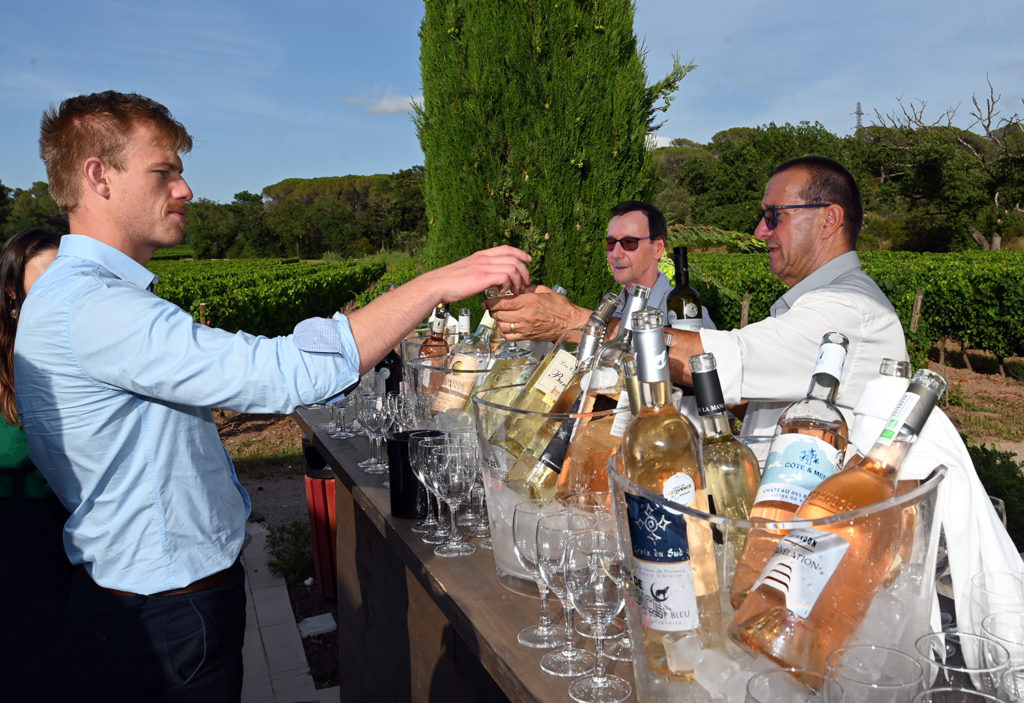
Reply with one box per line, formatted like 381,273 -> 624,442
654,87 -> 1024,252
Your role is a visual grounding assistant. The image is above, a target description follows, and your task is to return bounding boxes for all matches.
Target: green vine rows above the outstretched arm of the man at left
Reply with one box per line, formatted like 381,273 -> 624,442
150,259 -> 386,337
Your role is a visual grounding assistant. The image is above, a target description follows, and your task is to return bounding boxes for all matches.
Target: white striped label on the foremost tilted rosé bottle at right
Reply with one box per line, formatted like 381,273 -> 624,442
754,527 -> 850,618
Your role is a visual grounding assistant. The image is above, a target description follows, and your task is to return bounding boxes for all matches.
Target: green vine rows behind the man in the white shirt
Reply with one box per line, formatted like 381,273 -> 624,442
690,251 -> 1024,364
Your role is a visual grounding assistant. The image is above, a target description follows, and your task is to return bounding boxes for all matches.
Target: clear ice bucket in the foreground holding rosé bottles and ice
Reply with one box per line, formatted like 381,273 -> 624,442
607,454 -> 946,702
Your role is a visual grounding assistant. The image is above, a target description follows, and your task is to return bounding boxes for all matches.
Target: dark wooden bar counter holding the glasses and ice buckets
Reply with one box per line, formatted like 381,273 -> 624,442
293,408 -> 635,703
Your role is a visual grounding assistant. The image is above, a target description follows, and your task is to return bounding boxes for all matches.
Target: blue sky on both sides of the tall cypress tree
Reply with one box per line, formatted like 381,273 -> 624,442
0,0 -> 1024,202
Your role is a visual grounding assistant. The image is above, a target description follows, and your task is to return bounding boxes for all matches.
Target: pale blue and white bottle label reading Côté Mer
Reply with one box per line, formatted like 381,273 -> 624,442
755,432 -> 843,506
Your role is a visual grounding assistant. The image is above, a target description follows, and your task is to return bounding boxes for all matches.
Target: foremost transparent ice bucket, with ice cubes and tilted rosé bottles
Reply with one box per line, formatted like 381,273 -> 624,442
607,455 -> 946,702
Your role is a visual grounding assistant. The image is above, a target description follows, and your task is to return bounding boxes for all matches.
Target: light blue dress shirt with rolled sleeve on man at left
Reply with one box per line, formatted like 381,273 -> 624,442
14,234 -> 359,594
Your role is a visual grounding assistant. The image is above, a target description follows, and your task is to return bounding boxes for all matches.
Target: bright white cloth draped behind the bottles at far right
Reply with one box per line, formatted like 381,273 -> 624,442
850,381 -> 1024,633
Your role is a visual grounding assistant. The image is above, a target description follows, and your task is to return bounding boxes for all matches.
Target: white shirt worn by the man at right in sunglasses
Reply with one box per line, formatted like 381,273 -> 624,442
700,252 -> 907,435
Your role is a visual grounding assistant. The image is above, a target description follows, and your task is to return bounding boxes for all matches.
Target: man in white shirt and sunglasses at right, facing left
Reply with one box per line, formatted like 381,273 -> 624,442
670,157 -> 907,435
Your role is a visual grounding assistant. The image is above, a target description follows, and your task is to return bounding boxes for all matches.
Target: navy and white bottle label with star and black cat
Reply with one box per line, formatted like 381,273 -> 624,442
626,493 -> 700,631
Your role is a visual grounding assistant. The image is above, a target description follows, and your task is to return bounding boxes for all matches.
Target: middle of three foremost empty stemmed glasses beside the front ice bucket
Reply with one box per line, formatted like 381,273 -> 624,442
537,512 -> 597,676
